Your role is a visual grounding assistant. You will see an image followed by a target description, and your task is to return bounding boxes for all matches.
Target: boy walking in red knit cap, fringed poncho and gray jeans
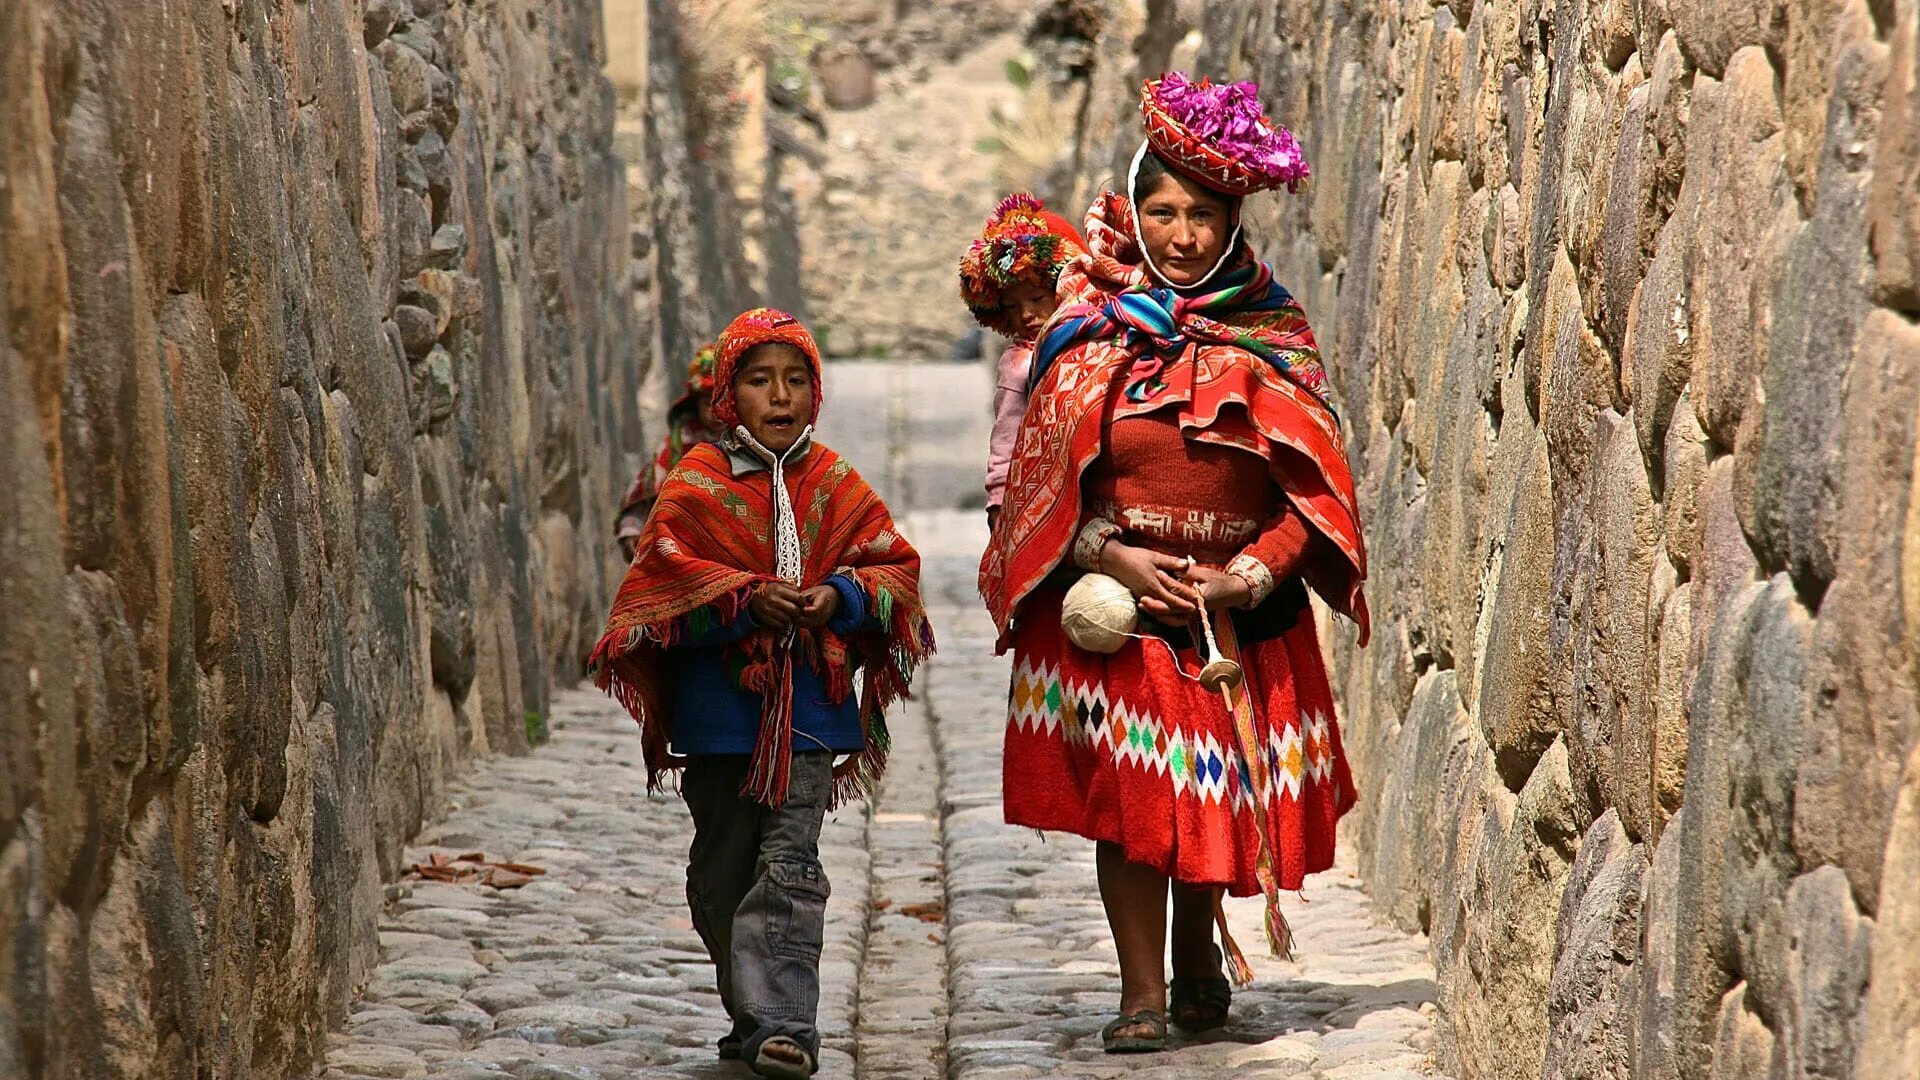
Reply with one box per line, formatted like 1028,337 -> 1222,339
591,307 -> 933,1080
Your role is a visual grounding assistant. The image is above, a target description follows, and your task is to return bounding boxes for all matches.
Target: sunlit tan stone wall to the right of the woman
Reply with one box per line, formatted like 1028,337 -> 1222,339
1039,0 -> 1920,1080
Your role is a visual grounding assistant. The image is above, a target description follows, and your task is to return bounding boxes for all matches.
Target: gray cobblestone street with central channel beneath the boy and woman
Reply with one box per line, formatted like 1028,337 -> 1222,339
326,499 -> 1434,1080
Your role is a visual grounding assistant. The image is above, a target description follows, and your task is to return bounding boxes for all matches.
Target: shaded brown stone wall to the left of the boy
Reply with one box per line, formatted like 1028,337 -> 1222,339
0,0 -> 641,1080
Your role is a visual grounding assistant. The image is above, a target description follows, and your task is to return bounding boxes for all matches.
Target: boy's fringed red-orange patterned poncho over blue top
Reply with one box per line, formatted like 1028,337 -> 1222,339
589,444 -> 933,805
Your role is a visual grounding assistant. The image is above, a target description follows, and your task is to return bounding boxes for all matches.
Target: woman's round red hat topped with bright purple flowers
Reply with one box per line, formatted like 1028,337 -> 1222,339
1140,71 -> 1309,196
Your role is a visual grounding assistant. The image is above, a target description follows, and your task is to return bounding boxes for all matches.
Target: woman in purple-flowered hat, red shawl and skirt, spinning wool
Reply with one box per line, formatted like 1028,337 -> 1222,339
981,73 -> 1367,1051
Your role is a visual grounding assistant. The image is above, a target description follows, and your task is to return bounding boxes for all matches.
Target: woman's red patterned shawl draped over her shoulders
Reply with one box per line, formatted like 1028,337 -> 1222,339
979,192 -> 1367,650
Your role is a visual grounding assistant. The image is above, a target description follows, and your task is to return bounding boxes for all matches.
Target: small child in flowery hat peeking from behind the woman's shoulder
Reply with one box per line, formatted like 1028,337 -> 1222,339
960,192 -> 1087,527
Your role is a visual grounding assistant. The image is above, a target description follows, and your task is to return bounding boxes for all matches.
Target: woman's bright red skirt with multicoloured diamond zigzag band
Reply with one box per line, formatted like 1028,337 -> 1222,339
1002,584 -> 1356,896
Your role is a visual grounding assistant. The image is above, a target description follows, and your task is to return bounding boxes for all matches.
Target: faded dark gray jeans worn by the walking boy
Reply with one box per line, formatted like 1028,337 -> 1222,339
680,751 -> 833,1061
